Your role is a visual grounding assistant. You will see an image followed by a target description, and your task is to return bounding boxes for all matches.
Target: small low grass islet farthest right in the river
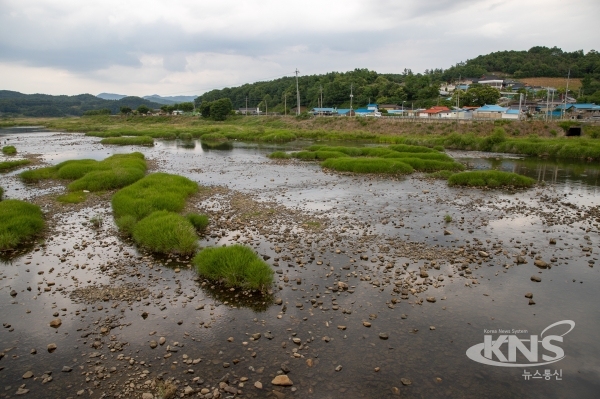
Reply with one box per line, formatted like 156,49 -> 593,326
448,170 -> 535,188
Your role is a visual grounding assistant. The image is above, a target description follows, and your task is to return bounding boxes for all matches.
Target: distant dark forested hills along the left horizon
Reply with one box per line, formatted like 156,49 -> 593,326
0,90 -> 161,116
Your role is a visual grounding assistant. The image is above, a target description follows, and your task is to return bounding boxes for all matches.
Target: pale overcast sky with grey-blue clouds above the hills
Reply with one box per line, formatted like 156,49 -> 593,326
0,0 -> 600,96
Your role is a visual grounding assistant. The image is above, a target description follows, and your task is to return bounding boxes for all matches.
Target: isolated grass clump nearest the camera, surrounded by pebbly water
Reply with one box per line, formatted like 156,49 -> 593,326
193,245 -> 273,291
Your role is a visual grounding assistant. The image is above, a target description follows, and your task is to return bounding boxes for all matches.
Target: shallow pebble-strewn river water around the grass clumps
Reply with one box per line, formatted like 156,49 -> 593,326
0,132 -> 600,398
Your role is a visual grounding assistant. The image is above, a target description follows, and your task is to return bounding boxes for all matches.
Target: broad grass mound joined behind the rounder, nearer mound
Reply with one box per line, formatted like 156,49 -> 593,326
112,173 -> 198,223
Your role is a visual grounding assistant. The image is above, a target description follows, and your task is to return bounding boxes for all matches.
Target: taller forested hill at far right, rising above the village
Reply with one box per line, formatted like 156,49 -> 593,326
440,46 -> 600,80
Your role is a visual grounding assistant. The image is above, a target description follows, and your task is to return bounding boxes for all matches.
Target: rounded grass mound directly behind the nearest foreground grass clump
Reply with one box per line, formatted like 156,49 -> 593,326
132,211 -> 198,254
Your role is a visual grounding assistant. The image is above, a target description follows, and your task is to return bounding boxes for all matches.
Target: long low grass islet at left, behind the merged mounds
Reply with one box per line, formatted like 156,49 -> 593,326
20,152 -> 146,191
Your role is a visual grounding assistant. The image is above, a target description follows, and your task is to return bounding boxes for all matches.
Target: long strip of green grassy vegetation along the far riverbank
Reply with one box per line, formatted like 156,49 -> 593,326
0,116 -> 600,160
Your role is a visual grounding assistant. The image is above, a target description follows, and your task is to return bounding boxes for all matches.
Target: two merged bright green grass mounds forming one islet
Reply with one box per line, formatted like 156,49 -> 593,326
112,173 -> 208,254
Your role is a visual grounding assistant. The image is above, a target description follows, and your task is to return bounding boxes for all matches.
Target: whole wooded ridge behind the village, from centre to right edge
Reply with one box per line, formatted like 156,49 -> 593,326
196,47 -> 600,112
